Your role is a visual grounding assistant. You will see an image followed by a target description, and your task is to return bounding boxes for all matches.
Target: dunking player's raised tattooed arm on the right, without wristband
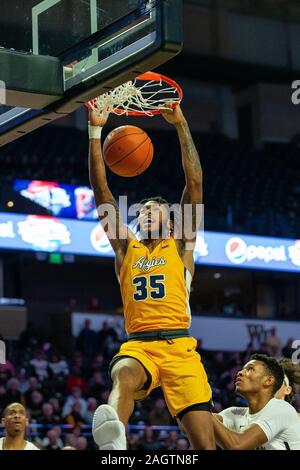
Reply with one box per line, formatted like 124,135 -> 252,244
162,105 -> 203,250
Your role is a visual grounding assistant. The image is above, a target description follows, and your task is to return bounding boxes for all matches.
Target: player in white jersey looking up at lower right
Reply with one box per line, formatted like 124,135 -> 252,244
214,354 -> 300,450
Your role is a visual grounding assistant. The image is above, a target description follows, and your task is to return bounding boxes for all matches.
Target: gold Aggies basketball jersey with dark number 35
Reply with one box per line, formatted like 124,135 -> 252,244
119,238 -> 192,333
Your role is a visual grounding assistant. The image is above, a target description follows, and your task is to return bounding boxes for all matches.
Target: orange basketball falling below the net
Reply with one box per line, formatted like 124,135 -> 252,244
103,126 -> 153,177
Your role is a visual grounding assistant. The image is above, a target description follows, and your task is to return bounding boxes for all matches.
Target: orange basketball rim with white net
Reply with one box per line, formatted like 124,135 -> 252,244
86,72 -> 183,116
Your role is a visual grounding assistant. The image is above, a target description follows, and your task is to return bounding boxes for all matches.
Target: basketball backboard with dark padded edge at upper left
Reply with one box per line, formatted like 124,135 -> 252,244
0,0 -> 182,145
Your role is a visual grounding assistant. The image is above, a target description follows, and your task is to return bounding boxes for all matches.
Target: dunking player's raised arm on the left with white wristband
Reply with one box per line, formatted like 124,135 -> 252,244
89,111 -> 134,253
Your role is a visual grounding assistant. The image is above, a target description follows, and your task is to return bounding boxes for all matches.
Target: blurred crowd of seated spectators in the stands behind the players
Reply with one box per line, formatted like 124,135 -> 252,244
0,320 -> 300,450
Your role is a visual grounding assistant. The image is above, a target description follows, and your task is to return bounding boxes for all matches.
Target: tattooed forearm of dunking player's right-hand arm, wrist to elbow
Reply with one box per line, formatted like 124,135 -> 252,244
176,120 -> 202,187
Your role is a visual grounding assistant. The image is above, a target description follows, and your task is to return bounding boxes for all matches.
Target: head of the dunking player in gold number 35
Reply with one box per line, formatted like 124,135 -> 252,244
139,201 -> 170,239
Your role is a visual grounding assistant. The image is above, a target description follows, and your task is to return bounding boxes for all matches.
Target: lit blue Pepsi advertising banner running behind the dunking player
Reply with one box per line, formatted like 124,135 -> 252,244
0,213 -> 300,272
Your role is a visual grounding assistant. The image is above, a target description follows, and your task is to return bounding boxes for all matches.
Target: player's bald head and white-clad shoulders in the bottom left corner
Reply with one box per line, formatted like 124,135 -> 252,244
0,403 -> 40,451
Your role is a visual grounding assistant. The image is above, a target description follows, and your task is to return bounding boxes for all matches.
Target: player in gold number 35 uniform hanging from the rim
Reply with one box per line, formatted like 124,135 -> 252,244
89,105 -> 215,450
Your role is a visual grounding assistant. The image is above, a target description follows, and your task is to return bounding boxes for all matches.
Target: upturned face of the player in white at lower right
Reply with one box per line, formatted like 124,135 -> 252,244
235,360 -> 271,396
